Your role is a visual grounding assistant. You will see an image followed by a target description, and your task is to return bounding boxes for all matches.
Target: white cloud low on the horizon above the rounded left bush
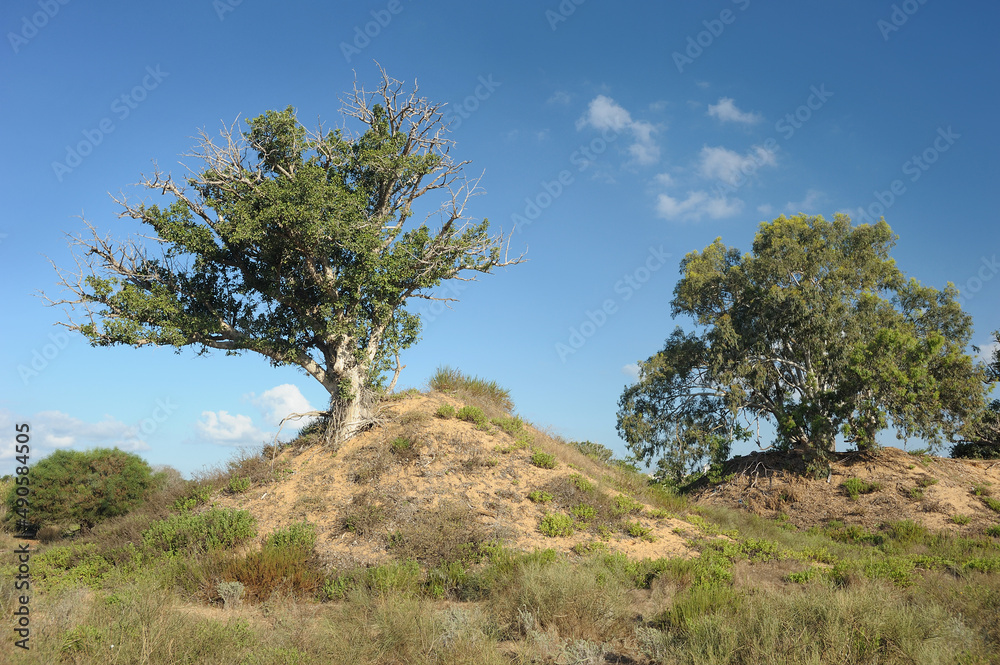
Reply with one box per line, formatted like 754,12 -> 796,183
0,410 -> 150,459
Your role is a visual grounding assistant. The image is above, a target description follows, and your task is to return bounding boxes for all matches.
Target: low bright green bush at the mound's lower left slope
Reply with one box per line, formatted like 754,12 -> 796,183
142,508 -> 257,554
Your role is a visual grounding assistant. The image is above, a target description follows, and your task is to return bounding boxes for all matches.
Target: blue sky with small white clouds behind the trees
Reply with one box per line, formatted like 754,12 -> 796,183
0,0 -> 1000,473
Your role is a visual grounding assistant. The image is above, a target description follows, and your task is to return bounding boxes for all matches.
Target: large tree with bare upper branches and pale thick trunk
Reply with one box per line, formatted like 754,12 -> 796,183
49,71 -> 521,440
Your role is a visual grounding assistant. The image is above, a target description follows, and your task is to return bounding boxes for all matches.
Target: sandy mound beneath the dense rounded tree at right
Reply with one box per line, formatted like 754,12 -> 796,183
694,448 -> 1000,534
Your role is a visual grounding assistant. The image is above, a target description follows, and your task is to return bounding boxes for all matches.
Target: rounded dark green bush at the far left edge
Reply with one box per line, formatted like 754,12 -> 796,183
5,448 -> 158,530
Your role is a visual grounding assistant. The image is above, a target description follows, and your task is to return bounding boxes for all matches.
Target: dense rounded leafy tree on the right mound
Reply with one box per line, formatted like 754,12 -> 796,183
618,214 -> 985,476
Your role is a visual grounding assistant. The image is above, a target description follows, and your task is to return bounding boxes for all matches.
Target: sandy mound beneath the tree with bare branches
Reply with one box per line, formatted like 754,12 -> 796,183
213,393 -> 694,567
